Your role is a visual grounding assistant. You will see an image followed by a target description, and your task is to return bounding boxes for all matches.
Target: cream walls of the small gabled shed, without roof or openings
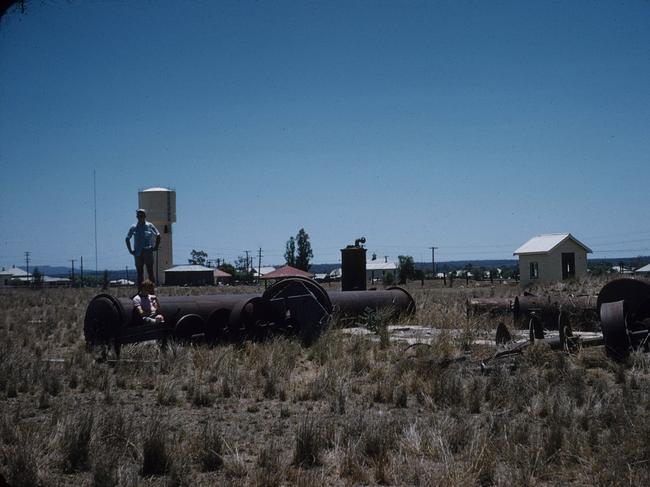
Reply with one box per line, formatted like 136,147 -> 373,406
519,239 -> 587,286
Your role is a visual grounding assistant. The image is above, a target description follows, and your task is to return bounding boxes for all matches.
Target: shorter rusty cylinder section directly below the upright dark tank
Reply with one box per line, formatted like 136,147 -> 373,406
329,287 -> 415,317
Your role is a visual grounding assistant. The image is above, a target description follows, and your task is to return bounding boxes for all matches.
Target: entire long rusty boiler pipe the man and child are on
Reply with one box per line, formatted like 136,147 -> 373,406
84,277 -> 415,352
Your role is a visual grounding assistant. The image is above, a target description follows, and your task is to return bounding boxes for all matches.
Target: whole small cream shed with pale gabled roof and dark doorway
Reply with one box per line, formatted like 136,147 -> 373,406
513,233 -> 591,286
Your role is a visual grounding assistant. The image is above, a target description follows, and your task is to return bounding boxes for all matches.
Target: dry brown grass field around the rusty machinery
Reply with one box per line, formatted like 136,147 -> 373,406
0,281 -> 650,487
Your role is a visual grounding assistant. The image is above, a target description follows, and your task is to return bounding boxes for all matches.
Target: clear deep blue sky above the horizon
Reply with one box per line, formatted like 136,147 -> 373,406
0,0 -> 650,270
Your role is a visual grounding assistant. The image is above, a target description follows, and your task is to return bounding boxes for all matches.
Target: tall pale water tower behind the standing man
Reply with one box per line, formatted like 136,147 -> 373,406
138,188 -> 176,284
